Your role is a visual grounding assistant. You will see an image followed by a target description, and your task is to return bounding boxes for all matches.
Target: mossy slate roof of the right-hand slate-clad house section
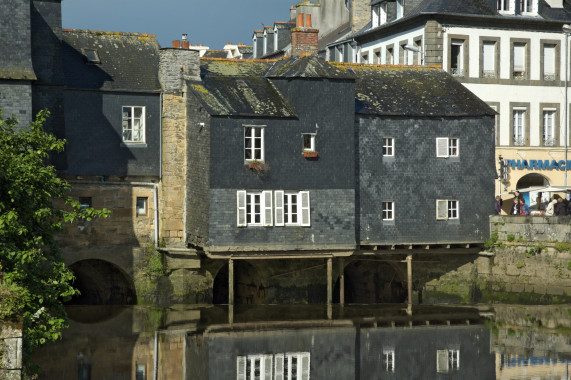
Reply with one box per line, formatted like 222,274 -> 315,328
331,62 -> 495,117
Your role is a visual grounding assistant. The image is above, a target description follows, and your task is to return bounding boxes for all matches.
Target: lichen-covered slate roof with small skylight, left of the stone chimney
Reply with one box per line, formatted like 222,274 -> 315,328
62,29 -> 161,92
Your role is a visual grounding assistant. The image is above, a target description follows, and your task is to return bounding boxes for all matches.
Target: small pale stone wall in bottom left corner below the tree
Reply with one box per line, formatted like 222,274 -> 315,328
0,321 -> 22,380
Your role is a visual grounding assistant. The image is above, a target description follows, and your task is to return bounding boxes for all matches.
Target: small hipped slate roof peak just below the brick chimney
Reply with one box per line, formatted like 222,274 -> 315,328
266,55 -> 351,79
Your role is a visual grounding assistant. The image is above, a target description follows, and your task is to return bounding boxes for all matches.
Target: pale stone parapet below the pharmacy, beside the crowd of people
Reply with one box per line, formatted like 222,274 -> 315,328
490,215 -> 571,242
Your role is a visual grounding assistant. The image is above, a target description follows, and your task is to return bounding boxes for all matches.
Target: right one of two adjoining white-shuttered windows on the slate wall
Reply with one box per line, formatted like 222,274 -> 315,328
274,190 -> 310,227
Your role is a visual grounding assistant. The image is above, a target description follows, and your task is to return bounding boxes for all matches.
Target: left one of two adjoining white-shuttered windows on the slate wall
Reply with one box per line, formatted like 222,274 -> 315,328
236,190 -> 273,227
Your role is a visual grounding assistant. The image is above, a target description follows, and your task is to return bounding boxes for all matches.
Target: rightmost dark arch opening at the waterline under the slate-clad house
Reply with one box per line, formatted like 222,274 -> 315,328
340,260 -> 407,304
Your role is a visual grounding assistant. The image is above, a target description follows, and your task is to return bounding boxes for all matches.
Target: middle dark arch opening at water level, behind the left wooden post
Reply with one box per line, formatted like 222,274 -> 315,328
212,260 -> 267,305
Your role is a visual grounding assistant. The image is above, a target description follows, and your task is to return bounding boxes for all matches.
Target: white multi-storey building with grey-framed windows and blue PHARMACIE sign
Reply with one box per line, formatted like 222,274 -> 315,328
328,0 -> 571,208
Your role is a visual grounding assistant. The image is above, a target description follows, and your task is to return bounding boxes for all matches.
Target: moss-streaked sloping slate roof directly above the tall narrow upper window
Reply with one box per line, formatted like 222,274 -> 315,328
189,75 -> 297,118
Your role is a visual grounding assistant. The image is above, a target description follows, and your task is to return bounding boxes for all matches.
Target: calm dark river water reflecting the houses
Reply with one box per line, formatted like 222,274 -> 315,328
30,305 -> 571,380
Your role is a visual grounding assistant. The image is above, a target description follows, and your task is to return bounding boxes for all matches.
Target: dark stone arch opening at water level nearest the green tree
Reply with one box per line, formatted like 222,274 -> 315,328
67,259 -> 137,305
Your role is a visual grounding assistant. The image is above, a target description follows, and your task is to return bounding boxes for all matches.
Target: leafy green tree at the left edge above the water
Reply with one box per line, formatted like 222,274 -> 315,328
0,111 -> 109,353
